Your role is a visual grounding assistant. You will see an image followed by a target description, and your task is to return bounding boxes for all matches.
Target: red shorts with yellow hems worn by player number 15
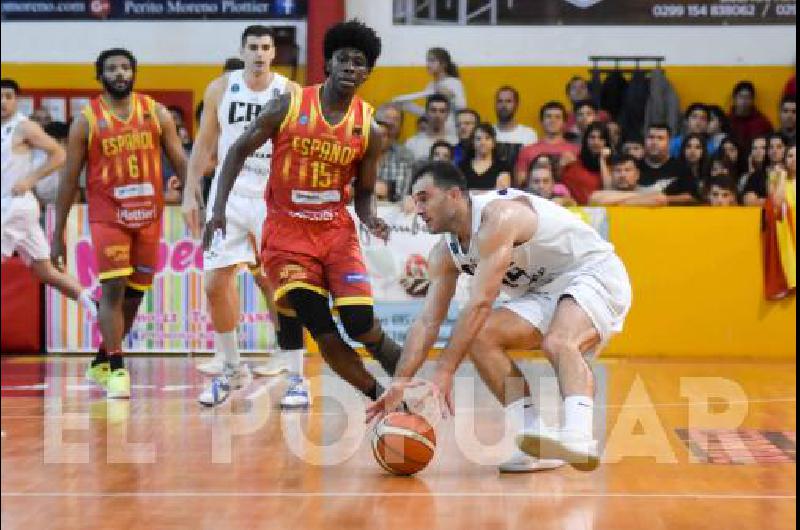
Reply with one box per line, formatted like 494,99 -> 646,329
261,216 -> 372,310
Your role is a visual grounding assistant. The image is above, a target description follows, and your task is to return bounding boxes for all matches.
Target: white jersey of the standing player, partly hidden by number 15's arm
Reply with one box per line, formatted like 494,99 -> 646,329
212,70 -> 289,197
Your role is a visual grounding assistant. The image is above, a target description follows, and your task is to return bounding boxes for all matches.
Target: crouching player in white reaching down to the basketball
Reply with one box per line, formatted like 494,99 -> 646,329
368,162 -> 631,472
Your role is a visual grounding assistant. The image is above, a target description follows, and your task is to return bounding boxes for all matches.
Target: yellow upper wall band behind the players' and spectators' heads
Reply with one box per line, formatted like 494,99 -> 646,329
2,63 -> 794,138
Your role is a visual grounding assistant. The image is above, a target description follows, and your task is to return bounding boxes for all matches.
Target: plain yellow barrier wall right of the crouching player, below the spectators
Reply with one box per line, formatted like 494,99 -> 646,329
608,207 -> 797,358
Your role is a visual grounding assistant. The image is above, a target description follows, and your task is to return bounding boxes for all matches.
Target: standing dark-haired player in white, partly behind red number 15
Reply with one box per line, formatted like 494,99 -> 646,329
183,25 -> 307,406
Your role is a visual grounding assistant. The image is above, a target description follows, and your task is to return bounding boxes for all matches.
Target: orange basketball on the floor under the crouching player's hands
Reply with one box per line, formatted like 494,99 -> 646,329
372,412 -> 436,475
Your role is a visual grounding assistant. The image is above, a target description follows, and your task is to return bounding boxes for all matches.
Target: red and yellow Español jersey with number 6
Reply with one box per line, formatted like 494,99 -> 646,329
83,92 -> 164,228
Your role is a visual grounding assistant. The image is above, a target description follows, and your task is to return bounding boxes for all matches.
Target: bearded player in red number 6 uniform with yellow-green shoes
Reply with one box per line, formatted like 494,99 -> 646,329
52,48 -> 186,398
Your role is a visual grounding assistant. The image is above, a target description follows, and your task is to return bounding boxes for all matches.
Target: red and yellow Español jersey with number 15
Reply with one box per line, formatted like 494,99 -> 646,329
266,85 -> 374,222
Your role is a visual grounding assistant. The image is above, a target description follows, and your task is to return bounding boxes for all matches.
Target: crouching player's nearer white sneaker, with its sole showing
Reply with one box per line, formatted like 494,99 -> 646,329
516,429 -> 600,471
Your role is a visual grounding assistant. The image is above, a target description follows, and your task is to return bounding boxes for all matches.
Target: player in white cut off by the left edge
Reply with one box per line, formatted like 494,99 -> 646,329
0,79 -> 97,316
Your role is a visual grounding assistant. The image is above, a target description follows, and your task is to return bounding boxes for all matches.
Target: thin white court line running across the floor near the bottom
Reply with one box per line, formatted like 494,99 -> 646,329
2,491 -> 797,500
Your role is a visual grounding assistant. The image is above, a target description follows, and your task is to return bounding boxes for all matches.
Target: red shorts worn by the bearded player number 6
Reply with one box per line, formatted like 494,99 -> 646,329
89,221 -> 161,291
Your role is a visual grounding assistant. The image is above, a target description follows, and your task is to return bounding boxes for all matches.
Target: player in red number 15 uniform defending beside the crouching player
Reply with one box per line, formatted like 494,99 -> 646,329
204,21 -> 400,407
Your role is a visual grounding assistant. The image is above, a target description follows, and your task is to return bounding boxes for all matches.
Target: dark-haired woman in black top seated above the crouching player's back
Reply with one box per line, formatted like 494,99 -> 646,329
458,123 -> 511,190
